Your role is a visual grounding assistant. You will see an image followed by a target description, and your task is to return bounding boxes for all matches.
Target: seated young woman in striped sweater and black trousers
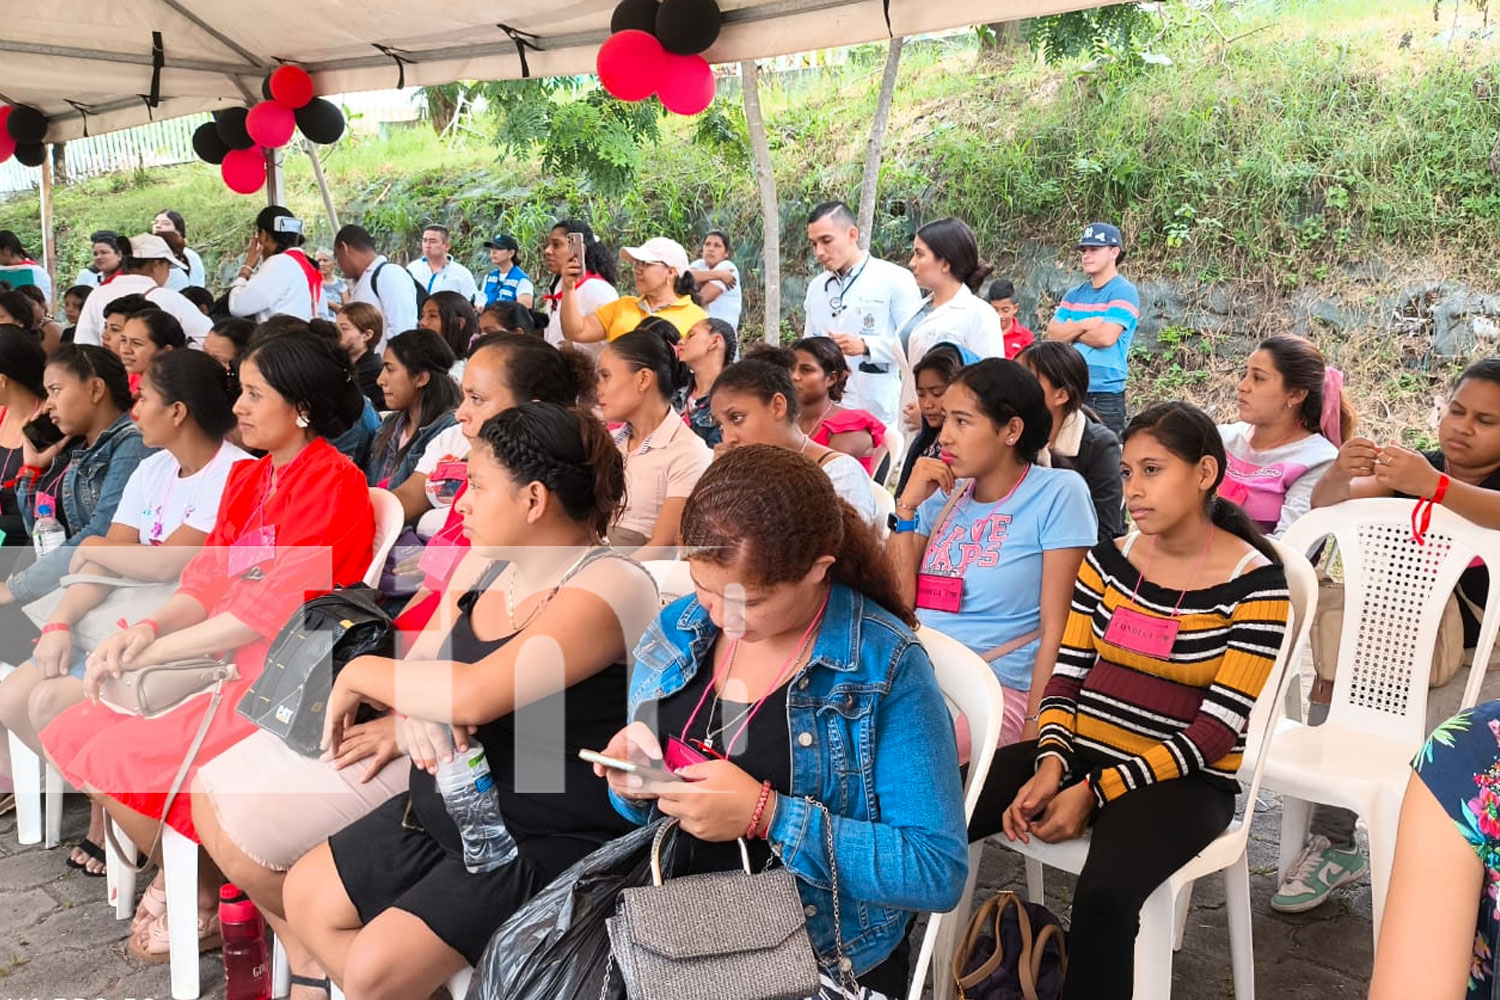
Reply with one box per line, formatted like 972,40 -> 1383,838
969,403 -> 1290,1000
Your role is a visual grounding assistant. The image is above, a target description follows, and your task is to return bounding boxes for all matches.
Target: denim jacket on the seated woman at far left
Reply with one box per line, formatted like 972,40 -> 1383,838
11,414 -> 155,604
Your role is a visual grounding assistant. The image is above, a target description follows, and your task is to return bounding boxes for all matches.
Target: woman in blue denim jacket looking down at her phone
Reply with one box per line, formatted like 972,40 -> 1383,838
596,445 -> 968,1000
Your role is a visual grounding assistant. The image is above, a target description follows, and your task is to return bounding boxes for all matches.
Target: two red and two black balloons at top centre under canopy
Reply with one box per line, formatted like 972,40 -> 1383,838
596,0 -> 723,115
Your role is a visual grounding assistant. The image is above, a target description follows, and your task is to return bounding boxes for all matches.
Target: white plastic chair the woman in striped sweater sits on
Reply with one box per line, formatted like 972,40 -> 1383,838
933,541 -> 1317,1000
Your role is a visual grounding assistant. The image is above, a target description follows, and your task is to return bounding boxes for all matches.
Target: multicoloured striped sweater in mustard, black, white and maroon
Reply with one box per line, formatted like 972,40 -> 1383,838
1038,541 -> 1292,805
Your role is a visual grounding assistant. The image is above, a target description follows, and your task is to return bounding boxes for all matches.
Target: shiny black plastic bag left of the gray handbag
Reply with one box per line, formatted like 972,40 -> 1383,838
467,820 -> 678,1000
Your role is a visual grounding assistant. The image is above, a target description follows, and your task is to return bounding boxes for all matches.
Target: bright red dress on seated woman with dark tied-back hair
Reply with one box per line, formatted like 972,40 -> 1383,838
42,438 -> 375,840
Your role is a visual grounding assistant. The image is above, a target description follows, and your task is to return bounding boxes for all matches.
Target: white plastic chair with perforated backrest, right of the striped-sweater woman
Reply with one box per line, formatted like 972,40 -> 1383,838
1266,499 -> 1500,940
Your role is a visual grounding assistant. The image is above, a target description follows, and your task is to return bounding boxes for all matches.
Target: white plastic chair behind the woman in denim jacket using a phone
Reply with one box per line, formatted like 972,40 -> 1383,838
900,626 -> 1005,1000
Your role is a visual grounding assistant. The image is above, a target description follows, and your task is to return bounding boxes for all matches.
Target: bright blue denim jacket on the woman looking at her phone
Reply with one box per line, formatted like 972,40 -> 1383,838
611,583 -> 969,975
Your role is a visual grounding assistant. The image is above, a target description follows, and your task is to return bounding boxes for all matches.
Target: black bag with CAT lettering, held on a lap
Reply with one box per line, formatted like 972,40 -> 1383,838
236,586 -> 396,757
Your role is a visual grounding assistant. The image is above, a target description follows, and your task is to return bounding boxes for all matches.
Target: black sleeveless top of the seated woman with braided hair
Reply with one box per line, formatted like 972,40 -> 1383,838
411,562 -> 633,871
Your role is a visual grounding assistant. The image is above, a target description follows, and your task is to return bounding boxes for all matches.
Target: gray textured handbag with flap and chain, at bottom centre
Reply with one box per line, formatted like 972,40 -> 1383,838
600,820 -> 848,1000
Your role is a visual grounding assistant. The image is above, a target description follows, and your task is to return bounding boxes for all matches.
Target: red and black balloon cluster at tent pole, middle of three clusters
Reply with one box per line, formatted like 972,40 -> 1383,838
192,66 -> 344,195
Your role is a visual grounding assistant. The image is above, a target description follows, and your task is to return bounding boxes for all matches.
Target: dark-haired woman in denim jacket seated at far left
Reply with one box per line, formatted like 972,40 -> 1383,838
0,352 -> 153,644
